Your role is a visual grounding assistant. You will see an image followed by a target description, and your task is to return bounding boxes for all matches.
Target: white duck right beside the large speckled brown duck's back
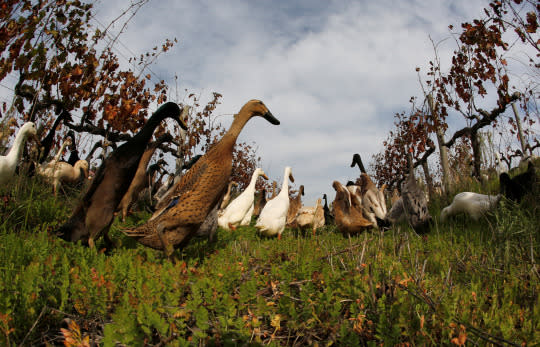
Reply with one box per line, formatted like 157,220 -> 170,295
218,168 -> 268,230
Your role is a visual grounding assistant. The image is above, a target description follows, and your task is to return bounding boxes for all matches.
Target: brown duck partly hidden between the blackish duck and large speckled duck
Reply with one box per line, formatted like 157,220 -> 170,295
116,133 -> 173,222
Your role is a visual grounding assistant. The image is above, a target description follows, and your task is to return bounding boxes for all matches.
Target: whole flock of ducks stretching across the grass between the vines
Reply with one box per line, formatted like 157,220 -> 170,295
0,100 -> 536,256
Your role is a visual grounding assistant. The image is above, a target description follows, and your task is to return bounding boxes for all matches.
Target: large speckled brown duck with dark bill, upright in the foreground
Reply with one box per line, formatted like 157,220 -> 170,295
123,100 -> 279,258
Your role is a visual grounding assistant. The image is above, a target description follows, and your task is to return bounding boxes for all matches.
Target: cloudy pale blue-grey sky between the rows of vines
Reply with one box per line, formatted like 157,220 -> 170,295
88,0 -> 502,205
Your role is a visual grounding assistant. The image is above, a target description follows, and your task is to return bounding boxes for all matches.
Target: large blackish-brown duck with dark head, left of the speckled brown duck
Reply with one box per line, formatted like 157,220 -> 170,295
56,102 -> 187,248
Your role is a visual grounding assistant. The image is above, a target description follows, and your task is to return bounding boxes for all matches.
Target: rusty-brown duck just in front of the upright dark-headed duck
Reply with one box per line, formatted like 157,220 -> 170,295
332,181 -> 374,235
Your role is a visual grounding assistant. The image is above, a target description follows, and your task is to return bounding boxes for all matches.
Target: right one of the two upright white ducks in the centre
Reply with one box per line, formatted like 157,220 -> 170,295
255,166 -> 294,239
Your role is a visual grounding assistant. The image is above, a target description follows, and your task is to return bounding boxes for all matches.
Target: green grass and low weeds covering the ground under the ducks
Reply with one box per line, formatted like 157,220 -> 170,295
0,175 -> 540,346
